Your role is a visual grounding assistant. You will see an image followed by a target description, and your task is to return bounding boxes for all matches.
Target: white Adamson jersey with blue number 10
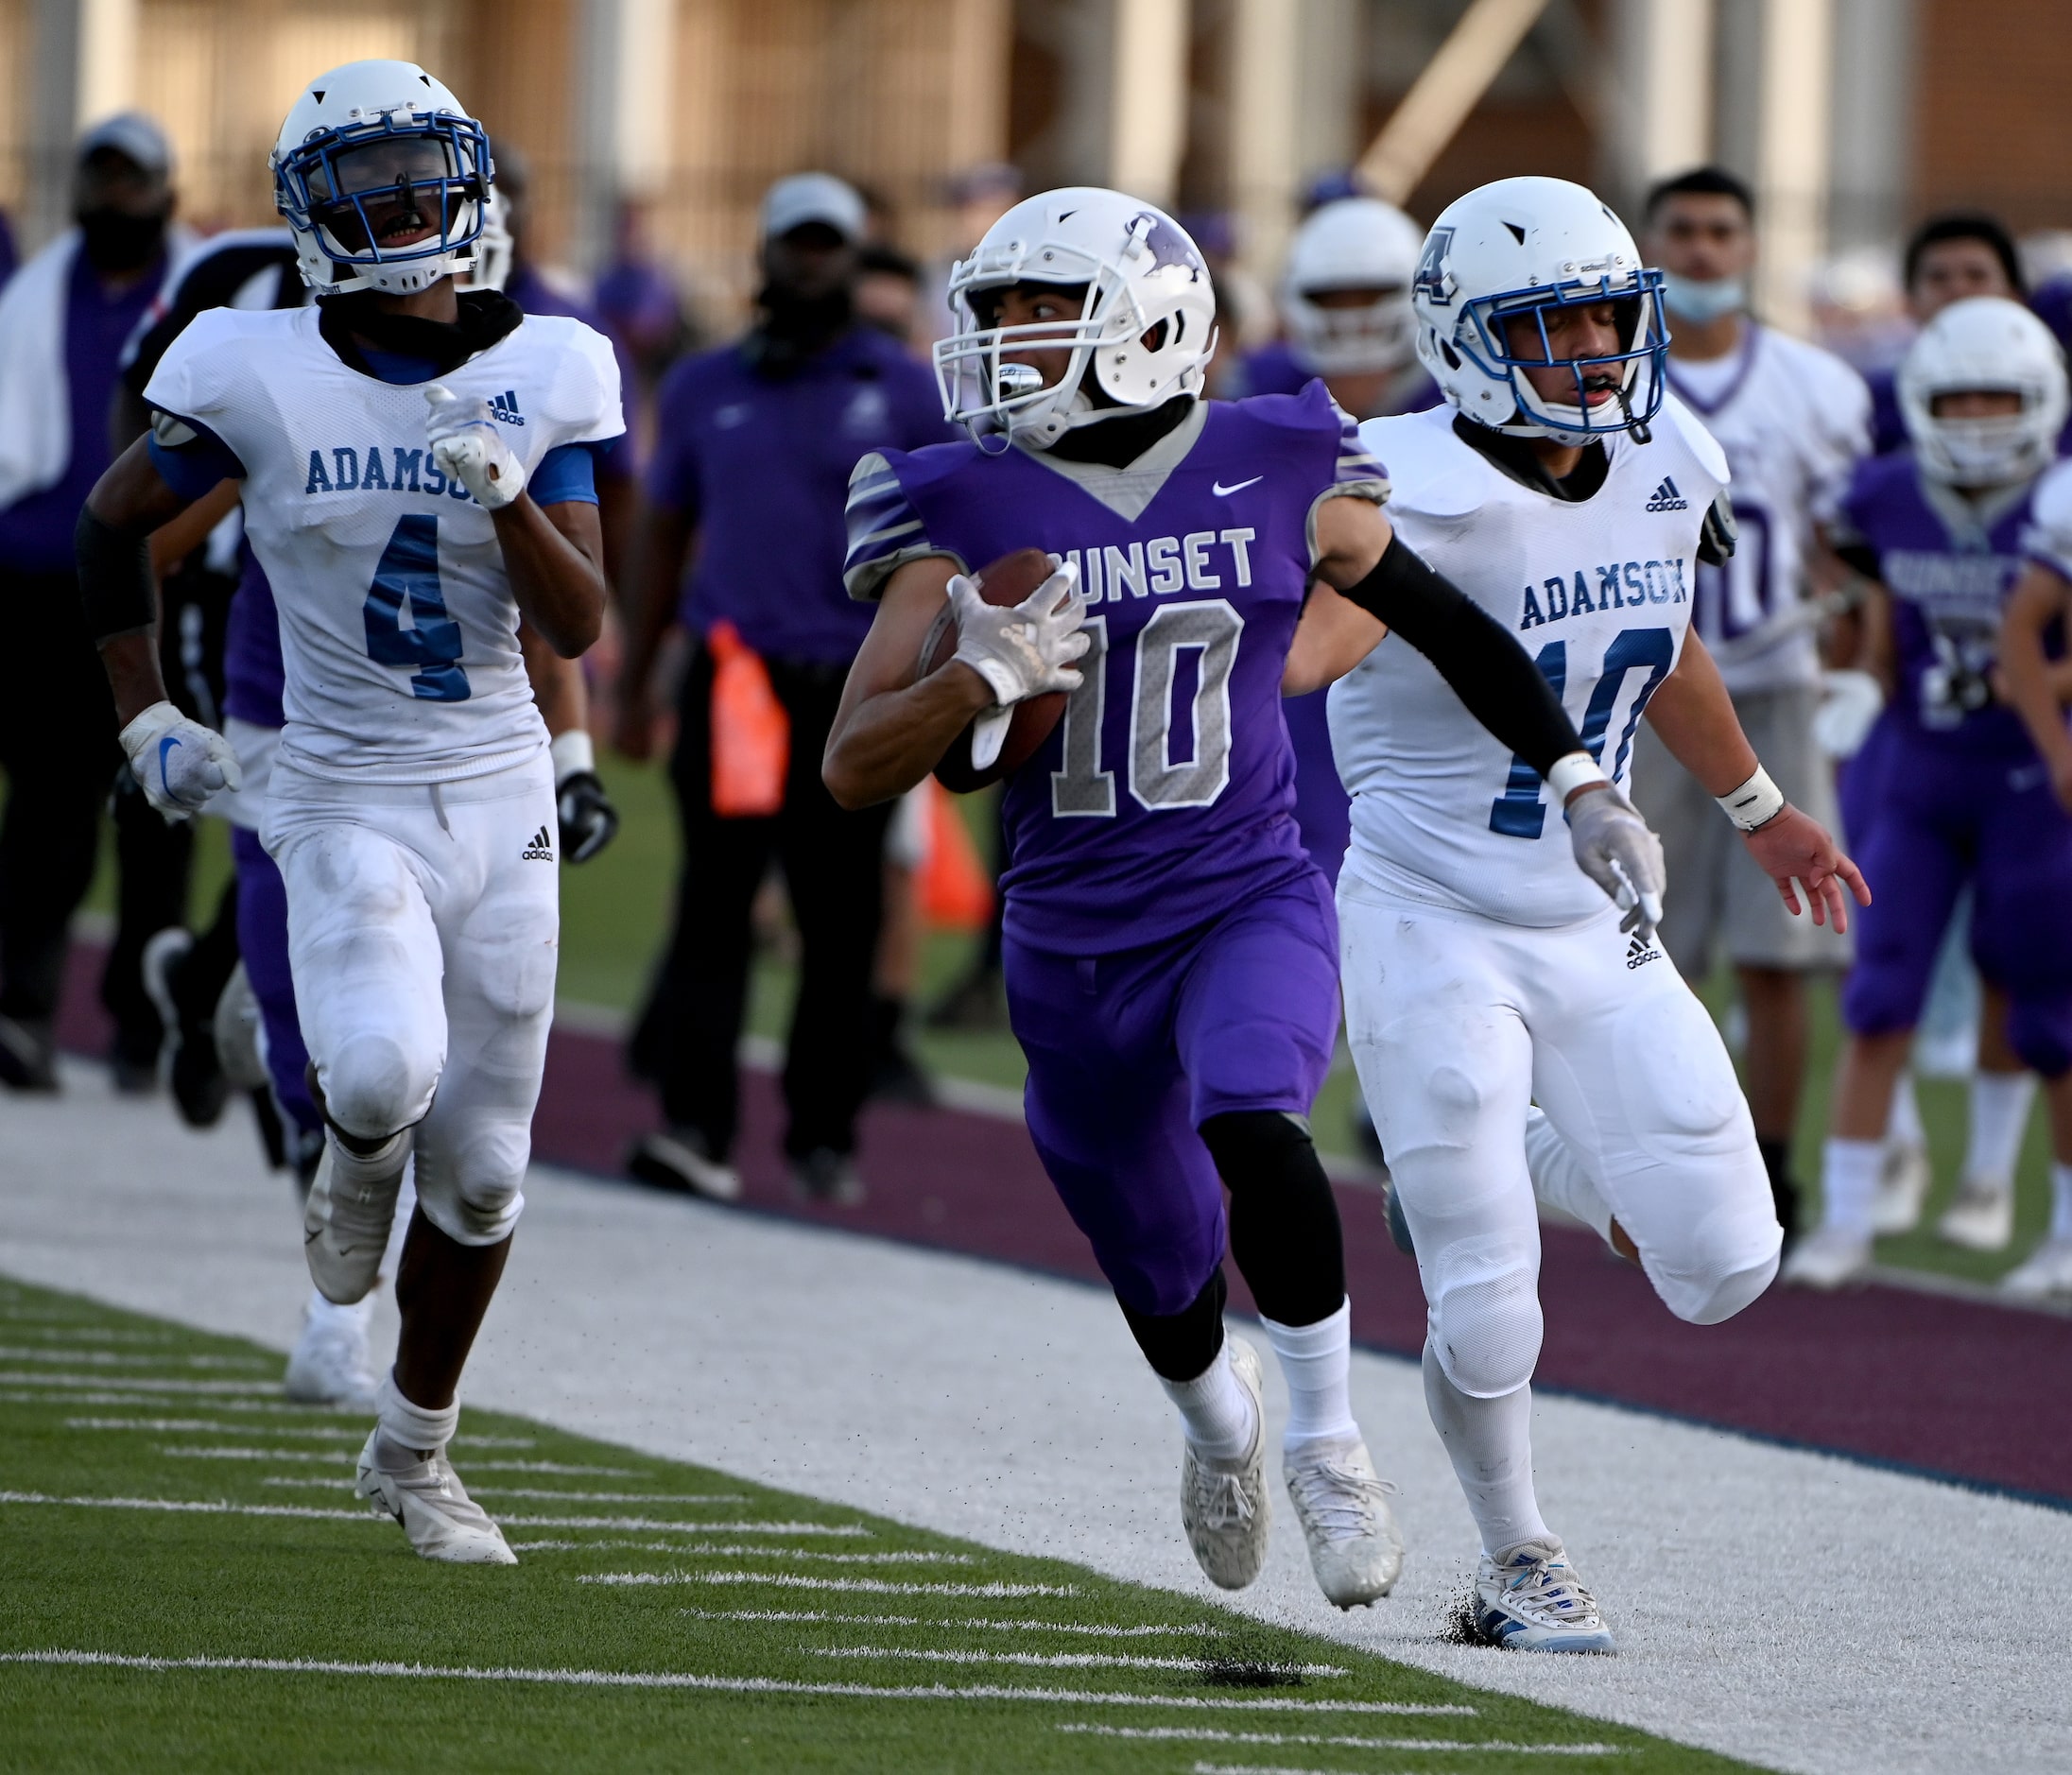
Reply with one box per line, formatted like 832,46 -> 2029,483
1328,396 -> 1726,926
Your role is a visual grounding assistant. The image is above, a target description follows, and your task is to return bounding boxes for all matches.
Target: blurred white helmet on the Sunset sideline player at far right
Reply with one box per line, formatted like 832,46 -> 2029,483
1898,296 -> 2065,487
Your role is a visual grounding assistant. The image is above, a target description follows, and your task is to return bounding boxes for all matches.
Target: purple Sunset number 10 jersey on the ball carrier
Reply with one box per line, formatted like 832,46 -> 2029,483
845,383 -> 1386,955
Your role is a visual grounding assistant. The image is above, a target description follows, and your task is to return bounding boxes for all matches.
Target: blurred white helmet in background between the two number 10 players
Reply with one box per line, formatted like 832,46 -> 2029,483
1281,197 -> 1424,375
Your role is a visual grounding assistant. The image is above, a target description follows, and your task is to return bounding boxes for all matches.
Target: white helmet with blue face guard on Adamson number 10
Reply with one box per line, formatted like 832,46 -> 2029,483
1411,176 -> 1670,443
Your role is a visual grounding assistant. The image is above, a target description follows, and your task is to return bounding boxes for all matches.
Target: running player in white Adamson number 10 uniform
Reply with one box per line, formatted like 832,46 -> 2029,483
1330,178 -> 1865,1651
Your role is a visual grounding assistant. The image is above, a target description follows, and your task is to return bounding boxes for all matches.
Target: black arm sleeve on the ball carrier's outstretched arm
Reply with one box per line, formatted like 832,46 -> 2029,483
1338,537 -> 1583,777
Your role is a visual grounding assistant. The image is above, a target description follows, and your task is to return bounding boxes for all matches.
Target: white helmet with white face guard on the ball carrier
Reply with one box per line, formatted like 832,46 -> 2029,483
935,186 -> 1217,450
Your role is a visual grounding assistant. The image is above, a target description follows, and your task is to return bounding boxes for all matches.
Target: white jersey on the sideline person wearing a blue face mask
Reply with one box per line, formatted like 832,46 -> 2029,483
1670,321 -> 1871,694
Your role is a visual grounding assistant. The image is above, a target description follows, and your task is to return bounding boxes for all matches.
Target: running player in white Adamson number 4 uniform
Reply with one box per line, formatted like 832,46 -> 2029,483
78,60 -> 624,1563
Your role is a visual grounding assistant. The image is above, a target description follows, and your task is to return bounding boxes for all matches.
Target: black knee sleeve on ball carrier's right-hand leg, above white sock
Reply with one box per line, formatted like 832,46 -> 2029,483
1201,1111 -> 1345,1325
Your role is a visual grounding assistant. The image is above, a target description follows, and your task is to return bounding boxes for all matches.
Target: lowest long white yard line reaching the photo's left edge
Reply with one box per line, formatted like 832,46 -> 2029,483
0,1651 -> 1492,1706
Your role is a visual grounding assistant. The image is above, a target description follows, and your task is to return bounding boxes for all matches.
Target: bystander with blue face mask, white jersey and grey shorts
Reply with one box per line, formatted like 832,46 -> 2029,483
1634,165 -> 1871,1236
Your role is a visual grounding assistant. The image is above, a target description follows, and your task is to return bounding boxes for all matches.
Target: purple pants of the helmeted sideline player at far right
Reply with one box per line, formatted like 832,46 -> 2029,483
1842,735 -> 2072,1079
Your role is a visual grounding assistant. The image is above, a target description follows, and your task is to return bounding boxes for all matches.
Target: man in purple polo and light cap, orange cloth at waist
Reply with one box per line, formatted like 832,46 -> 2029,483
617,172 -> 949,1201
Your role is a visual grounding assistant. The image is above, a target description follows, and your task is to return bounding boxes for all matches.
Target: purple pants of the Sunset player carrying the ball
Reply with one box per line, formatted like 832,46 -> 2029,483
1003,872 -> 1338,1316
